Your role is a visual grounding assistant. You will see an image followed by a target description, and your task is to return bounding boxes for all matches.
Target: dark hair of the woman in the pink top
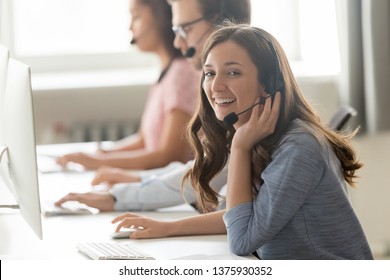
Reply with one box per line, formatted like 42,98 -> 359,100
138,0 -> 182,58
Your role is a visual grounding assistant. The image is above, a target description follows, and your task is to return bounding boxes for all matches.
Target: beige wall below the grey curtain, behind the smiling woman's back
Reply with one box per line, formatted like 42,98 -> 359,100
350,131 -> 390,258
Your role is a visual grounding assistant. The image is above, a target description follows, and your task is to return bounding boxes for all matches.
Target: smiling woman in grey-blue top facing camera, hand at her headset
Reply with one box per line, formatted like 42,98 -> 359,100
113,25 -> 373,259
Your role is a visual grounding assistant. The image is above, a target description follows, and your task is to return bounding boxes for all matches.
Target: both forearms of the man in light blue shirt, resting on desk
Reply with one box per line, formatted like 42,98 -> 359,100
55,162 -> 186,211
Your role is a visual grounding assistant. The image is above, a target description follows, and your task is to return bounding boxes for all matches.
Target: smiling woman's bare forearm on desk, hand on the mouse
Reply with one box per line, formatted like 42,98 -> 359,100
112,210 -> 226,239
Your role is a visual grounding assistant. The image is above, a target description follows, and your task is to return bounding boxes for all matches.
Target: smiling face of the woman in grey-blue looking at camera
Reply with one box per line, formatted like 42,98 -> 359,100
203,41 -> 266,128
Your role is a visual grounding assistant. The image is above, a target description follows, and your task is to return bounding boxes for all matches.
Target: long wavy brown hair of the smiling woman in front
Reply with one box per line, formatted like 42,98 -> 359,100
183,24 -> 363,212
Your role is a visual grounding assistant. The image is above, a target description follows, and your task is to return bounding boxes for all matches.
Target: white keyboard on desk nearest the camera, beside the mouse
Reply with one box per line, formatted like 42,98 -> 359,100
77,242 -> 154,260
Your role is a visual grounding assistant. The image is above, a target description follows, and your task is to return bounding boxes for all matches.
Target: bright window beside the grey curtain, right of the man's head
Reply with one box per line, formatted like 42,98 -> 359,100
252,0 -> 340,75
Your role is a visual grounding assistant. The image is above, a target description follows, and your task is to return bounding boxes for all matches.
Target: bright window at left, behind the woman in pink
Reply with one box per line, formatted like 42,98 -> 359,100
0,0 -> 157,71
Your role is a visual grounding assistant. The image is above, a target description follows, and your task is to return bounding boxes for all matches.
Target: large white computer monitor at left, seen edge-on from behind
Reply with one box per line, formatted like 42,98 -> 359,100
0,58 -> 42,239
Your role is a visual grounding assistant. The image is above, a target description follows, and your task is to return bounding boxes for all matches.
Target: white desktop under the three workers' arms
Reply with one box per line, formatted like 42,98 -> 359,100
0,144 -> 245,260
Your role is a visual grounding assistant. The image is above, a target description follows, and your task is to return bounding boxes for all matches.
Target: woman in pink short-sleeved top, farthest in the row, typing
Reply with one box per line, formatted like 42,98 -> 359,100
57,0 -> 200,169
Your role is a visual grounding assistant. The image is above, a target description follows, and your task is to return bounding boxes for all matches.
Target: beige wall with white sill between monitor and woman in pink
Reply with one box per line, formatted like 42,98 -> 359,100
32,68 -> 158,144
